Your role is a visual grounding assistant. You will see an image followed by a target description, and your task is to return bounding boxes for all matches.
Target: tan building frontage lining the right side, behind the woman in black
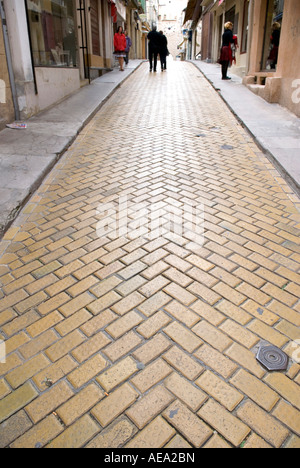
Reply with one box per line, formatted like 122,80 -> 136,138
185,0 -> 300,116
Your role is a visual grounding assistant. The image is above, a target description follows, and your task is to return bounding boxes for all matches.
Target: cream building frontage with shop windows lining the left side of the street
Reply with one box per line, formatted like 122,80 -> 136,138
0,0 -> 144,120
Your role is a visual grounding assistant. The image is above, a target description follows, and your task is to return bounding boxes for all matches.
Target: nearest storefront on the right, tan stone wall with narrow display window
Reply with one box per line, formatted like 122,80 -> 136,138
243,0 -> 300,117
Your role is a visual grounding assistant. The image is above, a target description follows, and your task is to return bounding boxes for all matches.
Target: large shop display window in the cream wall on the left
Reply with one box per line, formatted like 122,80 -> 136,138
26,0 -> 78,67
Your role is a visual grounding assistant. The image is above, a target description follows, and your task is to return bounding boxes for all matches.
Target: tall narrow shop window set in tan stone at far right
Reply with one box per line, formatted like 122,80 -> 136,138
261,0 -> 284,71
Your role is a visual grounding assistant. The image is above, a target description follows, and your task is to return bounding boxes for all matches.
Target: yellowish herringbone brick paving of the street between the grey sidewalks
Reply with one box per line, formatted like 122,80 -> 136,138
0,62 -> 300,448
